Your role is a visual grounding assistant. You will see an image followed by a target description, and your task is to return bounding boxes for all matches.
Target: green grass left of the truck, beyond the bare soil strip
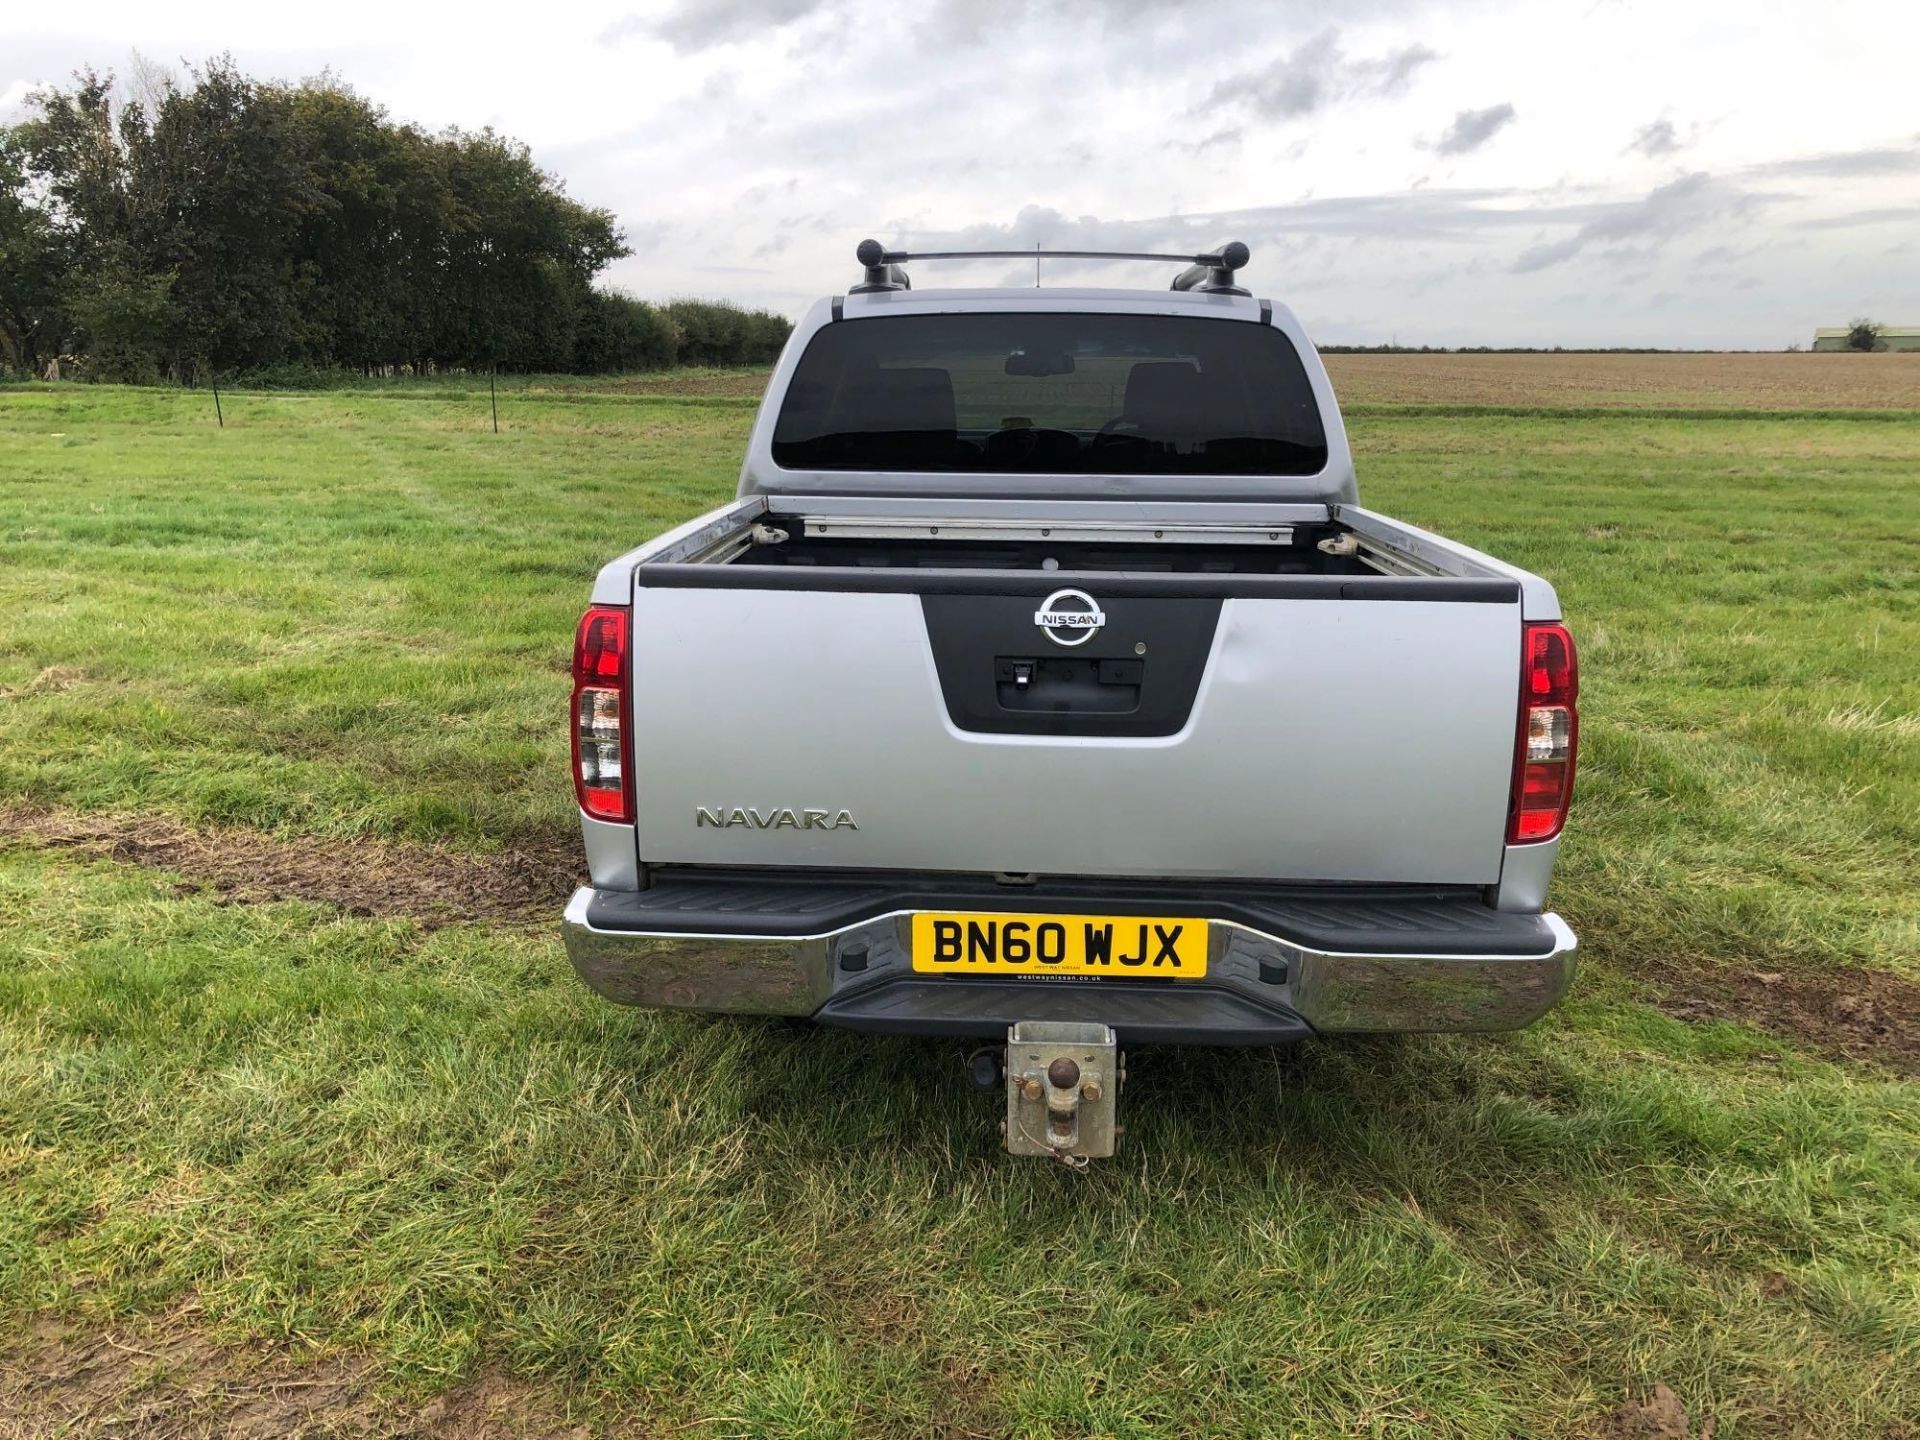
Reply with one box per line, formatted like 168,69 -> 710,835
0,388 -> 751,839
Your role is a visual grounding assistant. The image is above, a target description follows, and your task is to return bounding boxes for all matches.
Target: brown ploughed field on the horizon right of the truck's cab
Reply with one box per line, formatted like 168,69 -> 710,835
1325,353 -> 1920,411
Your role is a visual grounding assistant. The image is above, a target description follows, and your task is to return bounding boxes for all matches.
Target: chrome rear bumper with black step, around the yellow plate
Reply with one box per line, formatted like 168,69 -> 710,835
563,889 -> 1576,1044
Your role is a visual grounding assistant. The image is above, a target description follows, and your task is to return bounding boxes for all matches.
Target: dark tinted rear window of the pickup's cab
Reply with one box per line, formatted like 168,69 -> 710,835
774,313 -> 1327,474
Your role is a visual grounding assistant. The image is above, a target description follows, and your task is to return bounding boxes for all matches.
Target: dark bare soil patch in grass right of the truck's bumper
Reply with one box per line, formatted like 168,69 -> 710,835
1657,970 -> 1920,1075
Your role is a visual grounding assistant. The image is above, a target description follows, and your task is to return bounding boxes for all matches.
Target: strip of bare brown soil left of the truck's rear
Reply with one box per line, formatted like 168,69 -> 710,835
0,804 -> 582,925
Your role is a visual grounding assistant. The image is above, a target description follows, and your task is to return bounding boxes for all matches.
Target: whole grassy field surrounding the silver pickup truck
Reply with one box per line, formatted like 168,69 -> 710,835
0,355 -> 1920,1440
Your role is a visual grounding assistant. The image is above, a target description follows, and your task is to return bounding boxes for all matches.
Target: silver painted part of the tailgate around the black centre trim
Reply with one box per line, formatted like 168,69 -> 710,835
632,586 -> 1519,885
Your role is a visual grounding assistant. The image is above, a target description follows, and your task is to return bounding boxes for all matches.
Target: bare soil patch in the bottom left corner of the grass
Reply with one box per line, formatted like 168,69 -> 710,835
0,1321 -> 588,1440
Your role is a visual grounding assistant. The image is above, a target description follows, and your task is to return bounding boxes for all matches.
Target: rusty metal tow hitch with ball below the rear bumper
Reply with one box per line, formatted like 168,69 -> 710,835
968,1020 -> 1127,1169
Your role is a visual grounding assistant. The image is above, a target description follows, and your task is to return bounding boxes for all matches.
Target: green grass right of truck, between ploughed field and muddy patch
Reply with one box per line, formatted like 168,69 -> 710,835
1357,417 -> 1920,975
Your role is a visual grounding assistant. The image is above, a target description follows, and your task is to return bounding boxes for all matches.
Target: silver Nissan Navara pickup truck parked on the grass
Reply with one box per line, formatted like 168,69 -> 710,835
564,240 -> 1578,1164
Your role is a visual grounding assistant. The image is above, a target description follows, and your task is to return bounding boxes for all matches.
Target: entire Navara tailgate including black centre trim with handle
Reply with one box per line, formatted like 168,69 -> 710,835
632,564 -> 1521,885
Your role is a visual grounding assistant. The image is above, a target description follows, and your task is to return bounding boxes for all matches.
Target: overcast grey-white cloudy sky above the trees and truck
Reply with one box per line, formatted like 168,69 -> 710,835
0,0 -> 1920,349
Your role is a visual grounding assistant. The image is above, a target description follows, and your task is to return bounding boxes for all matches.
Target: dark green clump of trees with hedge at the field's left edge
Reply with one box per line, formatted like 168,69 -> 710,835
0,58 -> 791,382
